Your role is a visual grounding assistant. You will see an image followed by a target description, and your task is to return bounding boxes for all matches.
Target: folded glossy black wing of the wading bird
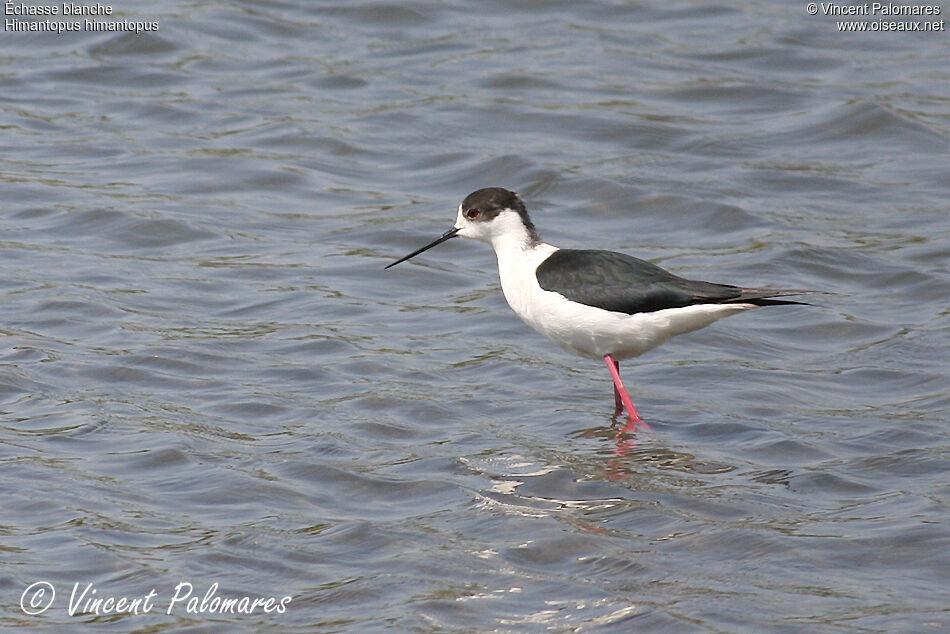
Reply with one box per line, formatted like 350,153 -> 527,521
535,249 -> 806,315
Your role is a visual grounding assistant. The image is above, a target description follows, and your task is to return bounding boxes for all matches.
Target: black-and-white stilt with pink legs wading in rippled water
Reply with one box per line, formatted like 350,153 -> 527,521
385,187 -> 809,423
